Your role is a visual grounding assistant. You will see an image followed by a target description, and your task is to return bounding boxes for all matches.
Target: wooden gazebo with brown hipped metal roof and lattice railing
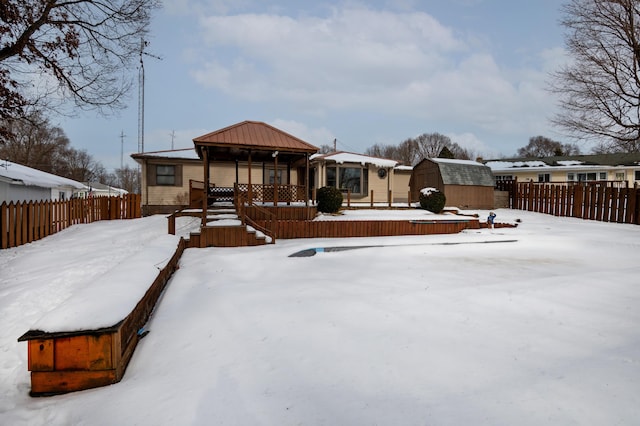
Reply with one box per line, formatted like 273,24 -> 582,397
193,121 -> 318,226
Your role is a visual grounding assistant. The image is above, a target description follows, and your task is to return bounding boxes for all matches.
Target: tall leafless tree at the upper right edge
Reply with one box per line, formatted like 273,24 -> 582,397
550,0 -> 640,152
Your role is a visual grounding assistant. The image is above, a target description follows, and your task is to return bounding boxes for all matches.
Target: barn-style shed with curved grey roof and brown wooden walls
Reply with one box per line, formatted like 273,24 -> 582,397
409,158 -> 495,209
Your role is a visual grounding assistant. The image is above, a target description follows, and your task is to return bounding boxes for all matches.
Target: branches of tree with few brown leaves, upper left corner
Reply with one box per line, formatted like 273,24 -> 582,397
0,0 -> 159,140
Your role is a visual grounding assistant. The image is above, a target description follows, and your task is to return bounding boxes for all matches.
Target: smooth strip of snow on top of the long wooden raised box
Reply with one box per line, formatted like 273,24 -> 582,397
32,235 -> 180,333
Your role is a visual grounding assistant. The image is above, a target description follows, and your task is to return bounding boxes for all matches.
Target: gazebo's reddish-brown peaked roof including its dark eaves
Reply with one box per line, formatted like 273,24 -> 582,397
193,121 -> 318,159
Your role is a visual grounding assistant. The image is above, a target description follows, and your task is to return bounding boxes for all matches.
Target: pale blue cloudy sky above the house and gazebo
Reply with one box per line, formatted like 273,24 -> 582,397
60,0 -> 568,170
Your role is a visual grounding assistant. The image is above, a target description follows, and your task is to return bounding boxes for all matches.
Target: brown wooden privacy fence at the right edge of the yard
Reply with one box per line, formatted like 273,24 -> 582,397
496,181 -> 640,225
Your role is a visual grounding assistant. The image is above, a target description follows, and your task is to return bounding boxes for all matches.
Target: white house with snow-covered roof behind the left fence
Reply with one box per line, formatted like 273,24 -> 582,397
0,160 -> 85,203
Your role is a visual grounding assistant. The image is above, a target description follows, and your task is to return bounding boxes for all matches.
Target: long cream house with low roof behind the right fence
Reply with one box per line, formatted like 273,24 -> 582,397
484,153 -> 640,187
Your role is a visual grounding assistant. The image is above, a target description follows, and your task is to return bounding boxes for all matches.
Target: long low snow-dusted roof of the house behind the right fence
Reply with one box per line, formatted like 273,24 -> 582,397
484,153 -> 640,170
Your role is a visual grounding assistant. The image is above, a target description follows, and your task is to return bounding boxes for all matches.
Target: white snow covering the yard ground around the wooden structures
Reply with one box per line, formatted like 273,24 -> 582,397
0,209 -> 640,426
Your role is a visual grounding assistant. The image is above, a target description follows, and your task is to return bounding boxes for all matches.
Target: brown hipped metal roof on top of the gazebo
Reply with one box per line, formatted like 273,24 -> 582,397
193,121 -> 318,153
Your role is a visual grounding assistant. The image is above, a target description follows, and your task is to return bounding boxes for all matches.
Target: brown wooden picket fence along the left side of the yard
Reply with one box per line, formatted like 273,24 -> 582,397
0,194 -> 141,249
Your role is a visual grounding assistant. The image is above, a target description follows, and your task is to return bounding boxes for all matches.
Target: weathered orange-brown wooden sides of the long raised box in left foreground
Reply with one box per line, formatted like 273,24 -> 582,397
18,239 -> 187,396
